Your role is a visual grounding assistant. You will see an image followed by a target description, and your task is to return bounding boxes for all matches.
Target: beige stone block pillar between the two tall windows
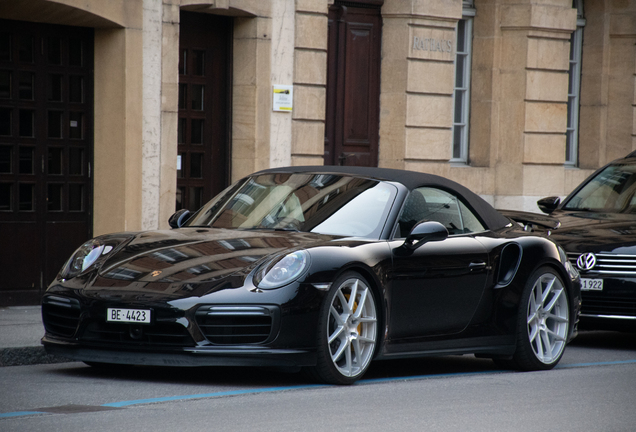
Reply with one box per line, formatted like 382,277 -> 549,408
490,0 -> 576,209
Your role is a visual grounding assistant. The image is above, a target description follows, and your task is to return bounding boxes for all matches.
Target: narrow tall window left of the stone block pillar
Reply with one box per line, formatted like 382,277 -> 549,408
450,0 -> 475,164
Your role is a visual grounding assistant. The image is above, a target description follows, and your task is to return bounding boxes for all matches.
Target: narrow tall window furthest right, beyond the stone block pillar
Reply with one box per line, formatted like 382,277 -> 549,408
565,0 -> 585,166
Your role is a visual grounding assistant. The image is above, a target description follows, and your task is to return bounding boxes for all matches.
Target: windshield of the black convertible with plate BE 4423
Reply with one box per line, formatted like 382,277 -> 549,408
185,173 -> 397,238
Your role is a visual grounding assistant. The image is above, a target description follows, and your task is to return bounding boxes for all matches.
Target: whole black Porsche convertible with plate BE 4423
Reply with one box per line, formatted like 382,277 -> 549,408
42,167 -> 580,384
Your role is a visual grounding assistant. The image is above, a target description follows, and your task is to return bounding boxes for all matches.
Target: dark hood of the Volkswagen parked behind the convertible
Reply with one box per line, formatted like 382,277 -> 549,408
551,210 -> 636,255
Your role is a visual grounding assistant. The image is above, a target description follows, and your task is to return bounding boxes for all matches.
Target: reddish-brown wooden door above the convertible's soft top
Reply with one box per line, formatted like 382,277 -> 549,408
325,4 -> 382,166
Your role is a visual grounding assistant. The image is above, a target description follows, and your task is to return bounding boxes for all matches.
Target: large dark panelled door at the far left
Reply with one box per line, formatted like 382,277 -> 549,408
0,20 -> 93,305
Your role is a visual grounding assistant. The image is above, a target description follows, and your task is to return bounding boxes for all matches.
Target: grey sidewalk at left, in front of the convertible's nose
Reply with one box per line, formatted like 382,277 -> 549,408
0,306 -> 69,366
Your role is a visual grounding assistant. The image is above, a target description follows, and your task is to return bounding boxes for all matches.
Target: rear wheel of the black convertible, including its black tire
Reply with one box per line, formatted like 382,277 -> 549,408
502,266 -> 570,371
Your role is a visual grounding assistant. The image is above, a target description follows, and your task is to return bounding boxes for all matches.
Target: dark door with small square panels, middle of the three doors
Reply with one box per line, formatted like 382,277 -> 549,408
176,12 -> 232,211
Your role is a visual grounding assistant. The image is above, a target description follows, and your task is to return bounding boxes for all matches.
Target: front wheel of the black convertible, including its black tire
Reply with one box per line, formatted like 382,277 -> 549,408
308,271 -> 379,384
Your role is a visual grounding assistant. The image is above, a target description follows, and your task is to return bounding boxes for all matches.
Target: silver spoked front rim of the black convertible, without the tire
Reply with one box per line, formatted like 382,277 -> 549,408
327,278 -> 377,377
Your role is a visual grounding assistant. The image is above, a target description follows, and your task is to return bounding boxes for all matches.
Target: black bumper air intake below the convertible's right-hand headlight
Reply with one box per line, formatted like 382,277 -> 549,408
196,306 -> 279,345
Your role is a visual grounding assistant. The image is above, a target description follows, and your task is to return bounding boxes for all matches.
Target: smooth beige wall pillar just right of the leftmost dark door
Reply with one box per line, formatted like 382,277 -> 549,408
93,21 -> 143,235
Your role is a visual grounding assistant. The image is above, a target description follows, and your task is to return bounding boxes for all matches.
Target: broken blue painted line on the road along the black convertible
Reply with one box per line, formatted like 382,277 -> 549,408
0,359 -> 636,419
